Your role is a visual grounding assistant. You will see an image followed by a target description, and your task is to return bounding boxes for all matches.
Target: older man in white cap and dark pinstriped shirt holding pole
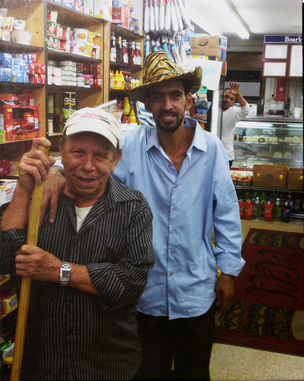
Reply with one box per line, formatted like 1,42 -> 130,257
0,108 -> 154,381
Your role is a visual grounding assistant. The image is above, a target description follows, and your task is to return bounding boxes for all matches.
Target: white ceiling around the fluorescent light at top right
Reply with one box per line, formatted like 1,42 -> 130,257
186,0 -> 303,41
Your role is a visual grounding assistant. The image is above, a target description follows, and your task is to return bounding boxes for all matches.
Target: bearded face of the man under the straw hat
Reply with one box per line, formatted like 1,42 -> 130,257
145,81 -> 192,132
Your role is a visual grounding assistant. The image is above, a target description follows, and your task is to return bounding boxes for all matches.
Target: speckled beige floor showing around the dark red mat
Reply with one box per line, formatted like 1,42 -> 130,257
210,219 -> 304,381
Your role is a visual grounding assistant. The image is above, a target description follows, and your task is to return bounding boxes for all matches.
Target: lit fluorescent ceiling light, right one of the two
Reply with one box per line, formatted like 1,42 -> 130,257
210,0 -> 250,39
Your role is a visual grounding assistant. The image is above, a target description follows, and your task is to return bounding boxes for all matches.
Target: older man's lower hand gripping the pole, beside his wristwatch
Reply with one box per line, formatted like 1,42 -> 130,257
15,245 -> 61,283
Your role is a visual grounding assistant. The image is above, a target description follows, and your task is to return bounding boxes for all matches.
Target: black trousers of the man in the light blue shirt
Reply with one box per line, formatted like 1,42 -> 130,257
134,303 -> 216,380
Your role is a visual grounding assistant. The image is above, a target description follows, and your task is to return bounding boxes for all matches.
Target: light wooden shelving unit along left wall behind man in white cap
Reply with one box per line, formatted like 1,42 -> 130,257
0,0 -> 144,160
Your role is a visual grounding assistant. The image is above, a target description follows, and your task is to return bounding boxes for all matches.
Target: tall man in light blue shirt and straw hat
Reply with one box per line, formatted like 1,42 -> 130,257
41,51 -> 244,380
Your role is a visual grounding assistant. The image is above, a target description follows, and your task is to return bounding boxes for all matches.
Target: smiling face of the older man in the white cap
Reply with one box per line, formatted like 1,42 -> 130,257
60,132 -> 121,207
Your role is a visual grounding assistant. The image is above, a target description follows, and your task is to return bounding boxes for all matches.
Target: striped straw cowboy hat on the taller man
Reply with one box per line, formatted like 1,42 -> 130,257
129,50 -> 202,103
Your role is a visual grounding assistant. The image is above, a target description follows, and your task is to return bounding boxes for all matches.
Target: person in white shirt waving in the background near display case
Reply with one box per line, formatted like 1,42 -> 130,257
221,81 -> 249,168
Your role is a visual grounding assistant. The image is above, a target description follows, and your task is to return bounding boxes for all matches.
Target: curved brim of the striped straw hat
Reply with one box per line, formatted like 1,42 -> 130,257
129,66 -> 202,103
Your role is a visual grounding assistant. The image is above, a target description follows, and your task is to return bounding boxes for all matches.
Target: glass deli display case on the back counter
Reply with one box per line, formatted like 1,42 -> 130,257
233,117 -> 303,168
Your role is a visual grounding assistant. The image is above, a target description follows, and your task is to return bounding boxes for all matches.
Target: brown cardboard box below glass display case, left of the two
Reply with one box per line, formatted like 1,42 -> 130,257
253,164 -> 288,189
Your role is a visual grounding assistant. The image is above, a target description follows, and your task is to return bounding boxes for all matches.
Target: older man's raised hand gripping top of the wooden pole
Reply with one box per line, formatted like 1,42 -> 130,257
18,138 -> 55,192
